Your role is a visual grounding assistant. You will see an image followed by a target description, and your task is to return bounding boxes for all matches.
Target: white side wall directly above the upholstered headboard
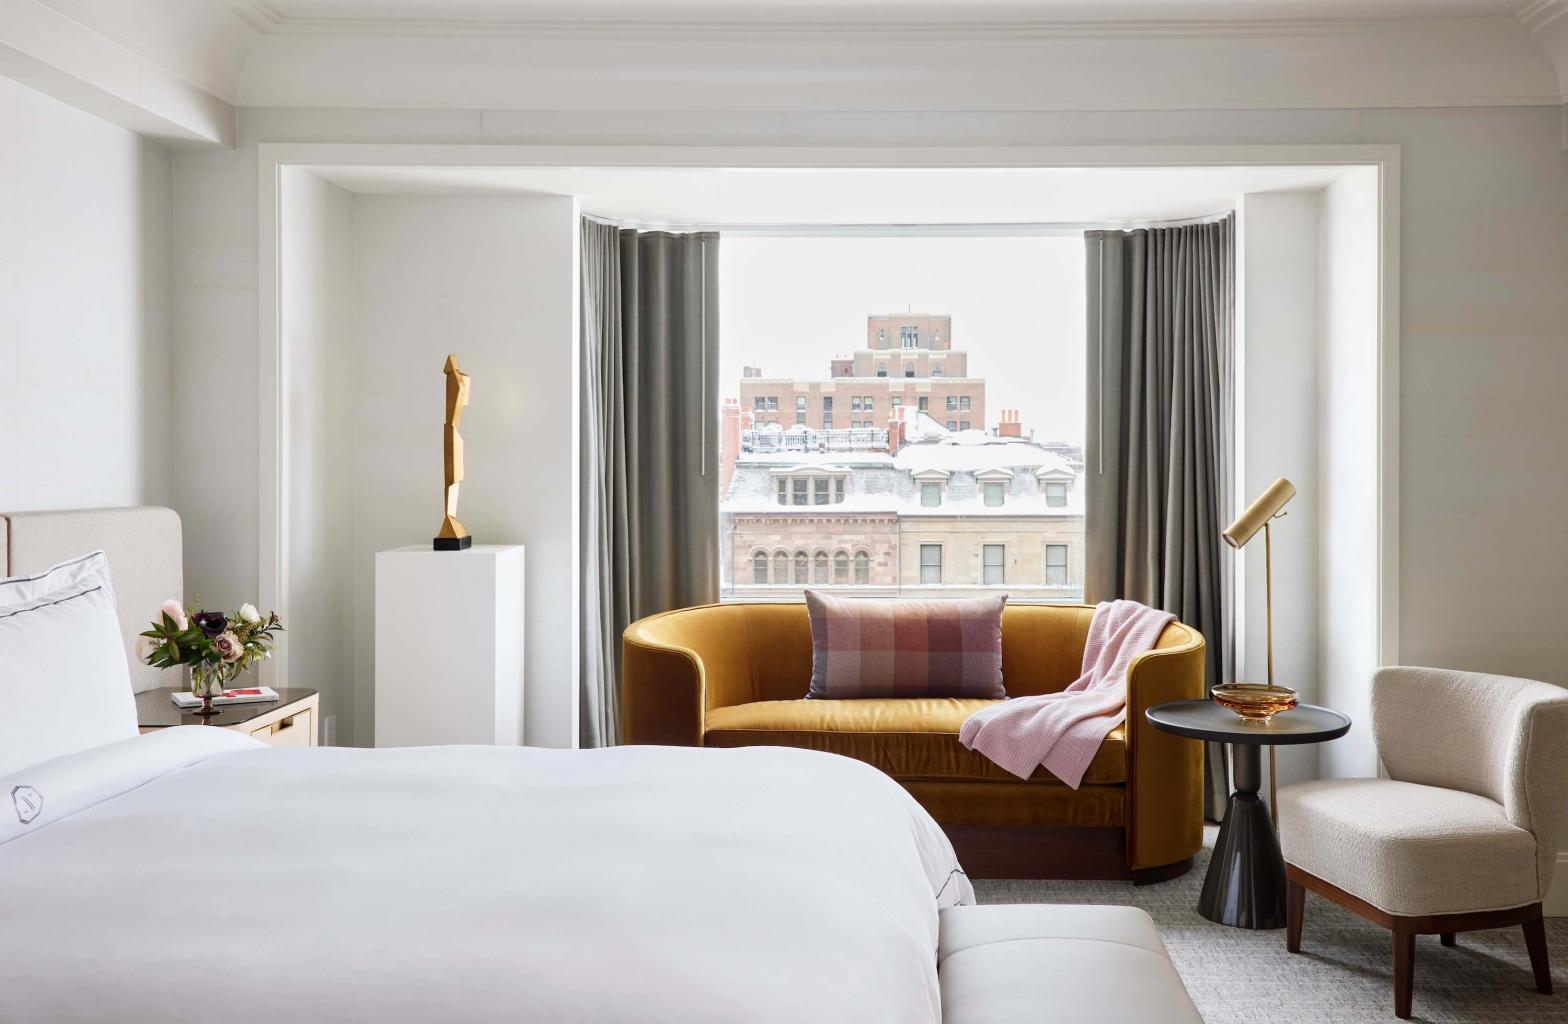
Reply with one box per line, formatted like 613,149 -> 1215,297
0,77 -> 173,510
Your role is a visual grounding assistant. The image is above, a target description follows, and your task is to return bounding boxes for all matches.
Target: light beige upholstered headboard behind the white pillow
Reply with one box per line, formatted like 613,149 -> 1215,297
0,508 -> 185,693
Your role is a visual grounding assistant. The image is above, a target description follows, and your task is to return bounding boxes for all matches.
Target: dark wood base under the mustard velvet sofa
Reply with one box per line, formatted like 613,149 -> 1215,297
942,825 -> 1192,884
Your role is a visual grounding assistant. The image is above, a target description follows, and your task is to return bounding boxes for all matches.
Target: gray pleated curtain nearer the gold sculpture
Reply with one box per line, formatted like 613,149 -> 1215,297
580,218 -> 718,746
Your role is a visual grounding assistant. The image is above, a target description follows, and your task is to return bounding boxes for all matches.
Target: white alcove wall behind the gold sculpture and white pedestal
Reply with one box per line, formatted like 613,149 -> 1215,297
349,196 -> 579,746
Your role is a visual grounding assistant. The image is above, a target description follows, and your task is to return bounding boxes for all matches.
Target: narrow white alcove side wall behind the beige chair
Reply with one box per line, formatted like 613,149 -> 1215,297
1298,168 -> 1386,778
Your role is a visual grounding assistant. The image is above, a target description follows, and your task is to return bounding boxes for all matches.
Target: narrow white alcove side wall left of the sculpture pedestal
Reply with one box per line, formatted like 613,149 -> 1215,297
276,168 -> 359,742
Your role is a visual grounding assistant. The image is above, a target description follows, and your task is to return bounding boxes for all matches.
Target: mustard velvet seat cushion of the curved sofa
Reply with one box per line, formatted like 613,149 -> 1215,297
702,698 -> 1127,786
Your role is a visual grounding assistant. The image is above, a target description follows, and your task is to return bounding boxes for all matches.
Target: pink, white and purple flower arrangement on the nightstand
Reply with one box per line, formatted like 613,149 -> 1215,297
136,599 -> 284,710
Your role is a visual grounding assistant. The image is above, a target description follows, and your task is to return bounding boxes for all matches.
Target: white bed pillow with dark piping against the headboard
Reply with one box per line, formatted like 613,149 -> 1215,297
0,552 -> 136,776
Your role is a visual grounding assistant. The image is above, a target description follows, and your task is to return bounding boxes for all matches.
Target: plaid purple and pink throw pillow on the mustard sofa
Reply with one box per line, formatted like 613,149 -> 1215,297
806,590 -> 1007,698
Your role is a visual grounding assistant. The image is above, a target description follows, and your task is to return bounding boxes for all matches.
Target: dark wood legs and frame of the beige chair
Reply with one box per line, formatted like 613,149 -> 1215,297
1284,862 -> 1552,1019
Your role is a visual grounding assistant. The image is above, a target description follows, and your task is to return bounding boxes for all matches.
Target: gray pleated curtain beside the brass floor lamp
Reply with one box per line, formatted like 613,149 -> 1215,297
1083,216 -> 1236,819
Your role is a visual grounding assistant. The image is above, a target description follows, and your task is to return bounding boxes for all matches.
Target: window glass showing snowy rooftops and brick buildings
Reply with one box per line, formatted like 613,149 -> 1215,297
718,227 -> 1093,604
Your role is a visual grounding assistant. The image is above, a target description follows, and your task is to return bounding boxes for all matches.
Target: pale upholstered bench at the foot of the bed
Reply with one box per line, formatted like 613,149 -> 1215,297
938,903 -> 1203,1024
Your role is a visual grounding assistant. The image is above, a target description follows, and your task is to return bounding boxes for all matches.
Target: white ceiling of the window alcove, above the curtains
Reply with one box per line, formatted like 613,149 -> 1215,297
312,166 -> 1345,226
